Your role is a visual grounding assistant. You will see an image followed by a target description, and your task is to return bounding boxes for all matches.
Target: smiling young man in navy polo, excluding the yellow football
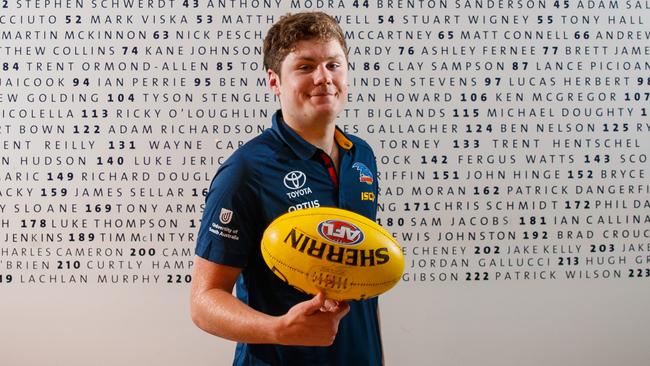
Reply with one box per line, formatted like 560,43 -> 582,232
191,13 -> 382,366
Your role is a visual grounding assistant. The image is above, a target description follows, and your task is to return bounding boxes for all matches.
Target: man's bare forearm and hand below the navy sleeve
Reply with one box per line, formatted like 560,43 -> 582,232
190,257 -> 350,346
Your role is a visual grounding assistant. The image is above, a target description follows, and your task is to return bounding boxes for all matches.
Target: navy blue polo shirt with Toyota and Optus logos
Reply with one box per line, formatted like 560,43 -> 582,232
196,111 -> 382,366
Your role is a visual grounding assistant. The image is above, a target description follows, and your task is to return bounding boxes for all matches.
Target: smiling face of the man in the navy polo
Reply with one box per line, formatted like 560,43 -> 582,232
268,40 -> 348,123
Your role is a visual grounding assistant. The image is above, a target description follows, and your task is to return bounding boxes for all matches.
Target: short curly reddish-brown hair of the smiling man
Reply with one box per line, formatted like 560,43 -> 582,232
263,12 -> 348,75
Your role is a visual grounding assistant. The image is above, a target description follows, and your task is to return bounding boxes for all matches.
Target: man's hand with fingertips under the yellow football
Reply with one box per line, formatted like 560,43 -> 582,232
277,292 -> 350,346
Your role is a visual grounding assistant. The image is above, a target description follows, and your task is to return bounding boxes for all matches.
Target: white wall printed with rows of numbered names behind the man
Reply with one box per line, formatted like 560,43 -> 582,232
0,0 -> 650,366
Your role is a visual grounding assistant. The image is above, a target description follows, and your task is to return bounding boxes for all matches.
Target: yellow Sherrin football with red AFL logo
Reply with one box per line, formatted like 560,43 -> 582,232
261,207 -> 404,300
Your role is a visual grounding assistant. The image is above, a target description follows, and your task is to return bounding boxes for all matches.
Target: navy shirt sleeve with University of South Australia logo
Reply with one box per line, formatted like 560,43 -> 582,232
196,155 -> 262,268
